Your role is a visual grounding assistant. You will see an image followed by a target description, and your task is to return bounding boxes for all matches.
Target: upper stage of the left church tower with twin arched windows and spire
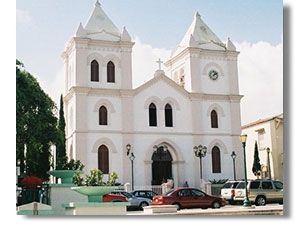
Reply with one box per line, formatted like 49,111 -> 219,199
62,0 -> 134,93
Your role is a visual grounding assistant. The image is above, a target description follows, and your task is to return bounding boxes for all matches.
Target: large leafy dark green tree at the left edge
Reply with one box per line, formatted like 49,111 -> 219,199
16,60 -> 57,181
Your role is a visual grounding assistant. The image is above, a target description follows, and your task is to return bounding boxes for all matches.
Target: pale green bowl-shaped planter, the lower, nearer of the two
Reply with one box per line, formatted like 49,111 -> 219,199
71,186 -> 118,202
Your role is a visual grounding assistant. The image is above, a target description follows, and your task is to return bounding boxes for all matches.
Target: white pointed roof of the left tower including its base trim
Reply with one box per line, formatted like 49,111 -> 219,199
76,0 -> 121,41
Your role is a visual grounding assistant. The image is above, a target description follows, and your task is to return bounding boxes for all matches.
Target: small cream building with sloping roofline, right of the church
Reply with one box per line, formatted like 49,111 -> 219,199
242,114 -> 283,181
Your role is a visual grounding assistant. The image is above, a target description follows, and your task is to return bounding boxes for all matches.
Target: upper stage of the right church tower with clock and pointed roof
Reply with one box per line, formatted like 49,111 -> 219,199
166,12 -> 239,95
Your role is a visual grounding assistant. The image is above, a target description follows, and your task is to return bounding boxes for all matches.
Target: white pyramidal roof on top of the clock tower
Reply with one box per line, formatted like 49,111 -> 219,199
172,12 -> 226,55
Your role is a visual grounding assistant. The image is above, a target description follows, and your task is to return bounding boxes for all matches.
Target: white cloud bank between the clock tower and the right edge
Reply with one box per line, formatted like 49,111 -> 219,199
235,39 -> 283,125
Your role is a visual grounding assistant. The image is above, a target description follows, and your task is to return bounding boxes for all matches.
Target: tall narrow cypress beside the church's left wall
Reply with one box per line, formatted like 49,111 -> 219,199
56,95 -> 66,167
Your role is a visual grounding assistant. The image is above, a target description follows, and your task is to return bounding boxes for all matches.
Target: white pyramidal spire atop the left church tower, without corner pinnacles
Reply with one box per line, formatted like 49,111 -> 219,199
84,0 -> 121,36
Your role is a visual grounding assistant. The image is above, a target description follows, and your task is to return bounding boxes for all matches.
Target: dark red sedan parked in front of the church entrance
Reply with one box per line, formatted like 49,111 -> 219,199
152,188 -> 226,210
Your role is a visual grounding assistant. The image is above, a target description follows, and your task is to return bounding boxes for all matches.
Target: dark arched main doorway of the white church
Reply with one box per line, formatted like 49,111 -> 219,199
151,146 -> 173,185
